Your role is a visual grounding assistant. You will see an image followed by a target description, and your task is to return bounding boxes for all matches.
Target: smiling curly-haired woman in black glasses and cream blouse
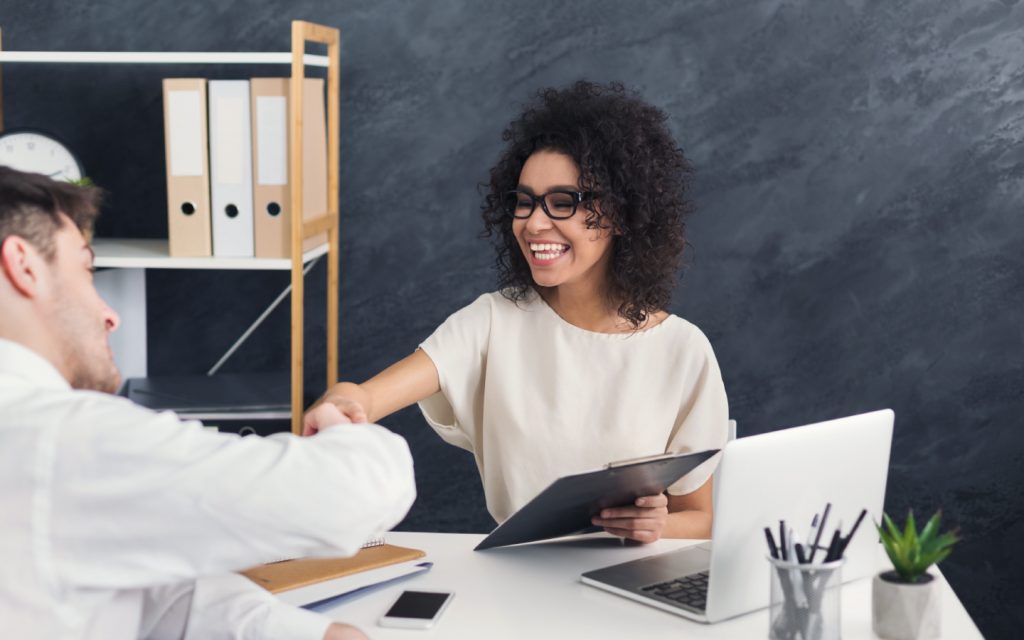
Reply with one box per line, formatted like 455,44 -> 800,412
305,82 -> 728,542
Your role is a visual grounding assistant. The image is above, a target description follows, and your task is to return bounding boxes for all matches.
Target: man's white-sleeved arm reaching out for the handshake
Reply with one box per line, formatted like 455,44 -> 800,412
49,394 -> 415,588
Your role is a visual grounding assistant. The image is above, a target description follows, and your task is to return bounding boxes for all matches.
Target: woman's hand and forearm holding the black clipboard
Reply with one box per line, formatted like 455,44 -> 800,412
592,478 -> 713,543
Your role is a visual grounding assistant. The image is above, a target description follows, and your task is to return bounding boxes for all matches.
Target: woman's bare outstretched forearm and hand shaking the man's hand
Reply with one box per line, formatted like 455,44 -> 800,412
303,349 -> 440,435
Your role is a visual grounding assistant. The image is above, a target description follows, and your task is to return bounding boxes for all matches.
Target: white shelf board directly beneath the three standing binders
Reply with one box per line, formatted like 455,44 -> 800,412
92,238 -> 328,271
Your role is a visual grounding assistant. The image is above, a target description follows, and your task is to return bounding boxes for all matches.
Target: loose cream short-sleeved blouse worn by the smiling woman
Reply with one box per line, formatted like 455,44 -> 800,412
420,293 -> 729,522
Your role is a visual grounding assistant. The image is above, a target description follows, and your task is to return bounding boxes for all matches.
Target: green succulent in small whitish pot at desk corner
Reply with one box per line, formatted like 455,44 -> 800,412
871,510 -> 959,640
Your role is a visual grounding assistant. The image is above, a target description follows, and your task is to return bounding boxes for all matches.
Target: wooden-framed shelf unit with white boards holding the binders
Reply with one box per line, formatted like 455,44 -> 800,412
0,20 -> 340,433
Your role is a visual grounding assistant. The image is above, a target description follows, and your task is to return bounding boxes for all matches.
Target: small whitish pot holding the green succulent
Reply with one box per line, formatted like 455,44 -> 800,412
871,571 -> 942,640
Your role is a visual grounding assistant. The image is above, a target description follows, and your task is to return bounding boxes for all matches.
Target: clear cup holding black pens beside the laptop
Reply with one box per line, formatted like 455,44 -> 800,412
768,556 -> 846,640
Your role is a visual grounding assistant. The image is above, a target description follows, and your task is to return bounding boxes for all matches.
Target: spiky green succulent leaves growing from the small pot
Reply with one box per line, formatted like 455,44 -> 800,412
876,509 -> 959,583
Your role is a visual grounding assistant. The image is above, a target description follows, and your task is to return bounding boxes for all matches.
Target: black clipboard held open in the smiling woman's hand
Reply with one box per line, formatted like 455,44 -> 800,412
474,449 -> 719,551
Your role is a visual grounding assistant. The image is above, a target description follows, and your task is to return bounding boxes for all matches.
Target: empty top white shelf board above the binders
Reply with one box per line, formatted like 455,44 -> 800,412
0,51 -> 328,68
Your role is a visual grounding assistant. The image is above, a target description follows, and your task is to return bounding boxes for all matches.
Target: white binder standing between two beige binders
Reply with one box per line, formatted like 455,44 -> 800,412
209,80 -> 253,258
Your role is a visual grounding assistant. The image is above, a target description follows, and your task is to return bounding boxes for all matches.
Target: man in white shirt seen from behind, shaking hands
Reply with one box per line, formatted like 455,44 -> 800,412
0,167 -> 416,640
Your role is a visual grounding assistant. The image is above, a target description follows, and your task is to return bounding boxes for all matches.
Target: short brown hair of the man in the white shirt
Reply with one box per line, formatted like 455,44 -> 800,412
0,167 -> 102,261
